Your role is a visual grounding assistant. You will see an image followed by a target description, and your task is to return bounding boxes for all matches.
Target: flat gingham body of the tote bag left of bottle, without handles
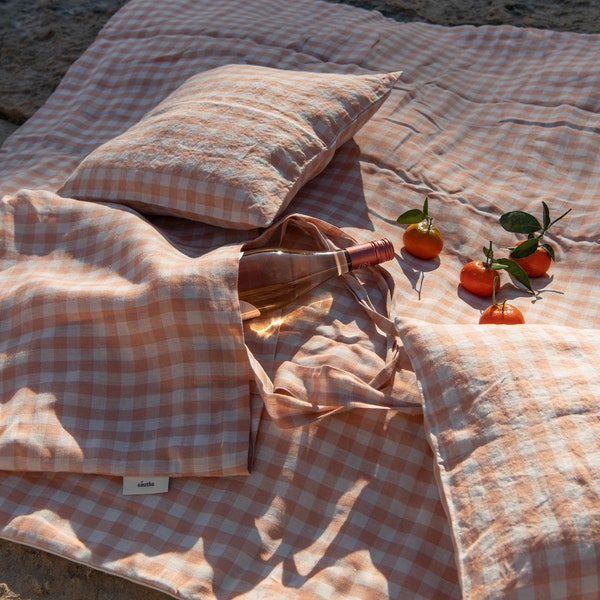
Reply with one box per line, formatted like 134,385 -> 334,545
0,191 -> 251,476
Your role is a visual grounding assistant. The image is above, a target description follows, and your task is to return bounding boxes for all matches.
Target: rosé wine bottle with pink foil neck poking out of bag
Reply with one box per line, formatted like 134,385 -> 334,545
238,239 -> 394,320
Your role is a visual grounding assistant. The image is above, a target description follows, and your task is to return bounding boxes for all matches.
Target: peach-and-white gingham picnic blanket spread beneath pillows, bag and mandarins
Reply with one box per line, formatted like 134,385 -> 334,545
0,0 -> 600,600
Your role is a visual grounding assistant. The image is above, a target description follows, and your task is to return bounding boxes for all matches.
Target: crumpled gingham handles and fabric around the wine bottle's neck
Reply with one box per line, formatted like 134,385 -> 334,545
243,215 -> 415,427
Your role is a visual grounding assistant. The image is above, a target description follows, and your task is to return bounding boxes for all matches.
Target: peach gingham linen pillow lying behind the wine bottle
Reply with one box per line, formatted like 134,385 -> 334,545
59,64 -> 400,229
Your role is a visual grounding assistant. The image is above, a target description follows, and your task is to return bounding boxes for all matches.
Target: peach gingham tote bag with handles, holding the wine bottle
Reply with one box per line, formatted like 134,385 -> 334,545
0,195 -> 406,477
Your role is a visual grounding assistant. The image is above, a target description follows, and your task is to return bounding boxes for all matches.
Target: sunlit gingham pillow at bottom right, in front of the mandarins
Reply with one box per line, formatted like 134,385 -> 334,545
400,322 -> 600,600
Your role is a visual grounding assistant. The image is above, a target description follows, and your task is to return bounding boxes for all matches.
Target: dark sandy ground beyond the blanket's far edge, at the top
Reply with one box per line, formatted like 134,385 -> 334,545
0,0 -> 600,142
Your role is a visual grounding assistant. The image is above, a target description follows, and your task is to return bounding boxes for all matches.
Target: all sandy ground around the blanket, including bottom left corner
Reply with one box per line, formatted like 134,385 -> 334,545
0,0 -> 600,600
